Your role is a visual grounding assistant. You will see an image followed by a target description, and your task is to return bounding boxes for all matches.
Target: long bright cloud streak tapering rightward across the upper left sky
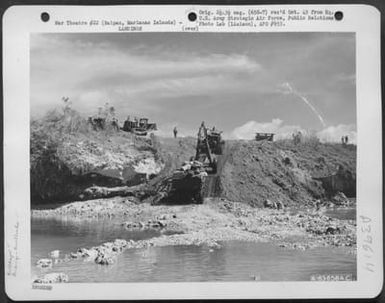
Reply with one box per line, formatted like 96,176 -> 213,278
31,35 -> 262,86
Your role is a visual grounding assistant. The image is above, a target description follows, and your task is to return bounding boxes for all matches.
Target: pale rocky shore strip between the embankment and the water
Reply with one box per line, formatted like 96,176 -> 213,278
32,197 -> 356,281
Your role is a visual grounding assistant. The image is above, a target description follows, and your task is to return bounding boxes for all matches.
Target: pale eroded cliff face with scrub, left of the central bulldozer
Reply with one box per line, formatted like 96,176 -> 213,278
30,112 -> 165,204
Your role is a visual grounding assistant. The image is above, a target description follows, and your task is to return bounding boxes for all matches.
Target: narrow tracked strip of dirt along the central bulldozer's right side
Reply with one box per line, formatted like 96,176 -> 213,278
203,141 -> 232,198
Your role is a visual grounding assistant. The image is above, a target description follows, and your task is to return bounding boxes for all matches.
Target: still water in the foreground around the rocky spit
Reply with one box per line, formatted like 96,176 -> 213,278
31,219 -> 356,282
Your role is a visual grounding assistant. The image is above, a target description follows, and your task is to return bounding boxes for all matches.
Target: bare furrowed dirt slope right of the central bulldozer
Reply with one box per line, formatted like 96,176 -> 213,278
220,141 -> 356,207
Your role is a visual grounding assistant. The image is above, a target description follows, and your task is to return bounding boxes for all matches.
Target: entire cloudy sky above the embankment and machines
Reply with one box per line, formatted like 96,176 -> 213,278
30,33 -> 356,140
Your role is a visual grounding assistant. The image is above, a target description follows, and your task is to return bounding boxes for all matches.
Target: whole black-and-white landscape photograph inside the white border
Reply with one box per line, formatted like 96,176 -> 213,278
30,33 -> 357,283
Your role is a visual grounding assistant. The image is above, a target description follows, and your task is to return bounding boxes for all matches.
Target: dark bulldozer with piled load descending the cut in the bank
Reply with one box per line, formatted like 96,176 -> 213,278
152,122 -> 225,204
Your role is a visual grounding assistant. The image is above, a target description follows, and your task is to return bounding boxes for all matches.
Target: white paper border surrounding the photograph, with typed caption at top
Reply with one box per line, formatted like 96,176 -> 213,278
3,5 -> 383,300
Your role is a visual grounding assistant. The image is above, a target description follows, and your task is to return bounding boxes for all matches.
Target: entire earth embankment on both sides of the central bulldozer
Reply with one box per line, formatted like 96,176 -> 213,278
31,111 -> 356,207
